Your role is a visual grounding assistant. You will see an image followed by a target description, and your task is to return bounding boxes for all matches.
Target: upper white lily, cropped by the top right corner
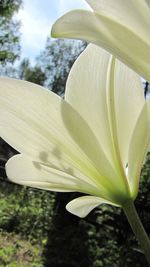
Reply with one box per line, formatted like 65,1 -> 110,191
52,0 -> 150,82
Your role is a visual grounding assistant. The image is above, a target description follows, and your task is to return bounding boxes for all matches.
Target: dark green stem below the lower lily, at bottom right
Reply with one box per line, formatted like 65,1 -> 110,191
123,201 -> 150,265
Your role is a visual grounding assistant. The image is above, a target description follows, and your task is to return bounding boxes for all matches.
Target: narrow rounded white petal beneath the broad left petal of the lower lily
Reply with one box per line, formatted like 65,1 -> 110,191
6,154 -> 99,193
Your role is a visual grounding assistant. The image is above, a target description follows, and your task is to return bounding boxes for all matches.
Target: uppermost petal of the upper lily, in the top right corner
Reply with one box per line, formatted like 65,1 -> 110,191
86,0 -> 150,32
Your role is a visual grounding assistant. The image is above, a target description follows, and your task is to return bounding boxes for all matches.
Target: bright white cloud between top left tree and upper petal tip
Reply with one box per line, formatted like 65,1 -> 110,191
17,0 -> 52,61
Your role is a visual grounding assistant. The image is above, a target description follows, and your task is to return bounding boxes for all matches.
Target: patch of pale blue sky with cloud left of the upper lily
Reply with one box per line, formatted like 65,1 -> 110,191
17,0 -> 88,62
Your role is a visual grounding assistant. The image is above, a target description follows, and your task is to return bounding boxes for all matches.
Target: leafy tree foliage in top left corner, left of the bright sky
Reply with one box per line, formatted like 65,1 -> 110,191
0,0 -> 22,65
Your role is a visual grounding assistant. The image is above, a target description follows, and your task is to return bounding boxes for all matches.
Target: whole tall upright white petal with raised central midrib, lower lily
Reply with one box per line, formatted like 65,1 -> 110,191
65,45 -> 145,195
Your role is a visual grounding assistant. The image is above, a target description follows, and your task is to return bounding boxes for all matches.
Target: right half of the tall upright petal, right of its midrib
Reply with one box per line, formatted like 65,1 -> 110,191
112,60 -> 145,167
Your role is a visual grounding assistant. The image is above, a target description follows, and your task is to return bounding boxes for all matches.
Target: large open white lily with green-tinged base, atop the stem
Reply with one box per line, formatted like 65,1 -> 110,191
0,45 -> 150,217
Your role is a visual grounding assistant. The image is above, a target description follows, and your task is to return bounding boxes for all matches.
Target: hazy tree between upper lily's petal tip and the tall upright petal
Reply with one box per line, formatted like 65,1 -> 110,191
37,38 -> 86,96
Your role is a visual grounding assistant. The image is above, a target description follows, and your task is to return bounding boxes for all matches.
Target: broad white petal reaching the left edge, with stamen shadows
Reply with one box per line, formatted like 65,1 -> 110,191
0,78 -> 111,192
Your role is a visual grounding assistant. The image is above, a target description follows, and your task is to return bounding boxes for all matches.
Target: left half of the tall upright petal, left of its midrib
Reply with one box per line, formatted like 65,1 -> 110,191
65,45 -> 113,172
